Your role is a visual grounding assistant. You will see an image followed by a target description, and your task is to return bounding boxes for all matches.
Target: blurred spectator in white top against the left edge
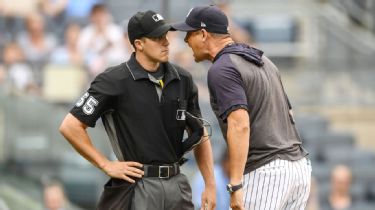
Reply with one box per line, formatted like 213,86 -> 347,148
0,43 -> 38,93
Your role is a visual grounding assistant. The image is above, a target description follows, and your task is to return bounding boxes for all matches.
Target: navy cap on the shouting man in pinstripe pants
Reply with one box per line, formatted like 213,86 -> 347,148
171,6 -> 229,34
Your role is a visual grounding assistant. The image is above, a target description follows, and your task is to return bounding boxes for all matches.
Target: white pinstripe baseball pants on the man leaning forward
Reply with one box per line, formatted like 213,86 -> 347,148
243,158 -> 311,210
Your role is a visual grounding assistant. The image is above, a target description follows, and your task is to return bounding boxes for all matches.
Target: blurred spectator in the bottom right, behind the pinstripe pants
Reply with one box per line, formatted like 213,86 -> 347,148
328,165 -> 353,210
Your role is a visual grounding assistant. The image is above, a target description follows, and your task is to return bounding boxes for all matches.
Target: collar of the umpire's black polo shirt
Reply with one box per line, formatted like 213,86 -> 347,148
125,52 -> 180,85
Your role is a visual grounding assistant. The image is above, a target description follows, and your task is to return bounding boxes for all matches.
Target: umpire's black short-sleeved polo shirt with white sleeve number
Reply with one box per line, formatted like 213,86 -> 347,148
71,54 -> 201,164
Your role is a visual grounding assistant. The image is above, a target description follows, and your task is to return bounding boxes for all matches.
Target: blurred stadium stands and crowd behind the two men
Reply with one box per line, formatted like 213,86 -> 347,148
0,0 -> 375,210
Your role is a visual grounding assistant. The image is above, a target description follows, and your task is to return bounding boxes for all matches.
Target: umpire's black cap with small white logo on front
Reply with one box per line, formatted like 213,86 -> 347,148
128,10 -> 171,44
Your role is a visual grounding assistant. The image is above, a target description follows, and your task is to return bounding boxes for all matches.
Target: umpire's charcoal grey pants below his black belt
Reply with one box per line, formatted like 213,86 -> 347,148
131,174 -> 194,210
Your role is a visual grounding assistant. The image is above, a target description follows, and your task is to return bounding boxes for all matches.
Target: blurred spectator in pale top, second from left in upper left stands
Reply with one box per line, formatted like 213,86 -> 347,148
18,13 -> 57,85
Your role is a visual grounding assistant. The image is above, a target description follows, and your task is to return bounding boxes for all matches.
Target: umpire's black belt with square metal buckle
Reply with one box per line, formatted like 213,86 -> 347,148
143,163 -> 180,179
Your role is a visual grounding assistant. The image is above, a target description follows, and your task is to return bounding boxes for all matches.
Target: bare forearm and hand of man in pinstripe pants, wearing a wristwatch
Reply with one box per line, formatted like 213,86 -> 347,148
227,109 -> 250,210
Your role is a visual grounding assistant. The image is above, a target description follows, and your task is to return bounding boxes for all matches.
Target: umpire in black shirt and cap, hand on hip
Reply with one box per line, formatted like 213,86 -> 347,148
60,10 -> 215,210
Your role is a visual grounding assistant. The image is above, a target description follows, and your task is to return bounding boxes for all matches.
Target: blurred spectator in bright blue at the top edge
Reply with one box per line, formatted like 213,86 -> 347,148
65,0 -> 103,26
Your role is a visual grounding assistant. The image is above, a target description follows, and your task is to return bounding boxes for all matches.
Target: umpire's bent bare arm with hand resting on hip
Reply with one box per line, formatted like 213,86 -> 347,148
59,113 -> 143,183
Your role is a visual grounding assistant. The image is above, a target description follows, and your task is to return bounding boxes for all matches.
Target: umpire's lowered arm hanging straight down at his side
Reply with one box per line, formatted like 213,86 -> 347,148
194,130 -> 216,210
